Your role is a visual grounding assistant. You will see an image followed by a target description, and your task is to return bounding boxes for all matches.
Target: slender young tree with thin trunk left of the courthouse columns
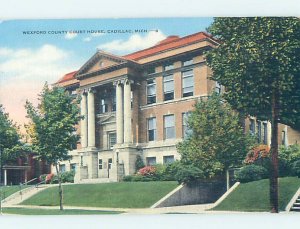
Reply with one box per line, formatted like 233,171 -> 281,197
25,84 -> 81,210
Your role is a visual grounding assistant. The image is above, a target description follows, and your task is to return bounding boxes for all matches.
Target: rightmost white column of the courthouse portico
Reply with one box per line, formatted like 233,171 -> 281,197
124,79 -> 132,143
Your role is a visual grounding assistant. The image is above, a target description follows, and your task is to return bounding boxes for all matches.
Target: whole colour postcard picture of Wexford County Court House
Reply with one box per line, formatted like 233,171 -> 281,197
0,17 -> 300,215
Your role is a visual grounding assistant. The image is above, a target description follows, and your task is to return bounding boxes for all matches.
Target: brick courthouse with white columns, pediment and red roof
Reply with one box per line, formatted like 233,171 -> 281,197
57,32 -> 299,182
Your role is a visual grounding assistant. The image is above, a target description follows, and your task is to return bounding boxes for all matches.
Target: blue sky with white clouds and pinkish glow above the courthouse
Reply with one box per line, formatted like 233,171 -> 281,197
0,17 -> 213,129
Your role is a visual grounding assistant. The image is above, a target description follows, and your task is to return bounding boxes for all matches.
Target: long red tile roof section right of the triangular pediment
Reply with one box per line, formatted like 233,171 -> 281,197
123,32 -> 215,60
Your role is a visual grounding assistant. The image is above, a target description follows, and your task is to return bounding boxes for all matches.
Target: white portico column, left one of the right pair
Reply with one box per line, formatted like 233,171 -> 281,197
115,81 -> 124,144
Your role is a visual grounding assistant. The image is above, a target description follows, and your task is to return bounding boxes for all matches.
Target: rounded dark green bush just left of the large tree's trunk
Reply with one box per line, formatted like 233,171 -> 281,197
235,165 -> 268,183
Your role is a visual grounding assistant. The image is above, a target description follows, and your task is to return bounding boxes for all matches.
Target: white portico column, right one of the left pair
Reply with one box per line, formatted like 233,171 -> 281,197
88,89 -> 95,147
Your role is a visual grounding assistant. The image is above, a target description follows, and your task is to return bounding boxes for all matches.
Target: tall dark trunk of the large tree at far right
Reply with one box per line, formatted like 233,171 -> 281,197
270,89 -> 279,213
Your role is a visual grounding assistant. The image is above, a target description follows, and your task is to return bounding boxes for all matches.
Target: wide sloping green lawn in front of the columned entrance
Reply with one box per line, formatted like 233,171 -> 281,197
21,181 -> 178,208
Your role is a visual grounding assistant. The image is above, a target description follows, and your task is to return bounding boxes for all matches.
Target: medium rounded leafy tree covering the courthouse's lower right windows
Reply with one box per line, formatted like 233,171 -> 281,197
177,94 -> 253,180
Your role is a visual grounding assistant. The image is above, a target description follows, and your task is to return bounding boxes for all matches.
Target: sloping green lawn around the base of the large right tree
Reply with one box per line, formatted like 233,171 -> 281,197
212,177 -> 300,211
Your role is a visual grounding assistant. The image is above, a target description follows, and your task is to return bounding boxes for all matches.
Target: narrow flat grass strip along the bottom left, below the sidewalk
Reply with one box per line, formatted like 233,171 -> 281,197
3,208 -> 123,215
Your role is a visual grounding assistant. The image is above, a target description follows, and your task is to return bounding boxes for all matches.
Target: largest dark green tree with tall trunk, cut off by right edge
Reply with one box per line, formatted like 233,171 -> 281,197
207,17 -> 300,212
